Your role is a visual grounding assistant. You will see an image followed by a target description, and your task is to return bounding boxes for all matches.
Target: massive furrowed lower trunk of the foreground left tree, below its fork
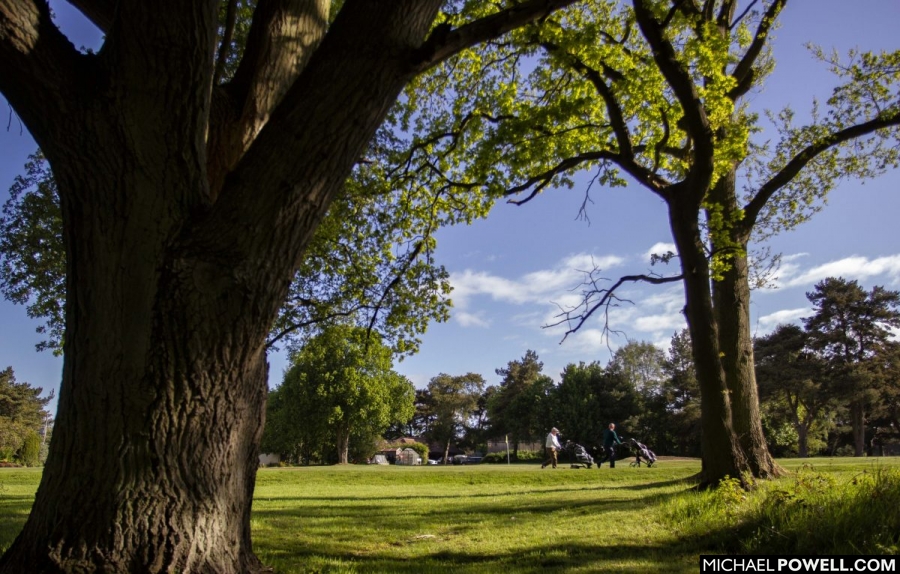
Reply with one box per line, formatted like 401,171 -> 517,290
2,137 -> 280,573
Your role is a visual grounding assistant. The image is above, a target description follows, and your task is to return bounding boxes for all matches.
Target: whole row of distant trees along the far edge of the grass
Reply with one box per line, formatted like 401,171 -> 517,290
264,278 -> 900,462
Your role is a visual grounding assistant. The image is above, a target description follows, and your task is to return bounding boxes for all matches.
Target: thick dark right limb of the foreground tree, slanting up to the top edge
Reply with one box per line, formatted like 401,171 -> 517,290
194,0 -> 442,321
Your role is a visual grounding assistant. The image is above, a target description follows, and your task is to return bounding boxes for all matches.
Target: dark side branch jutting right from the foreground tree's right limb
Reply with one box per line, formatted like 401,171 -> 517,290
413,0 -> 579,72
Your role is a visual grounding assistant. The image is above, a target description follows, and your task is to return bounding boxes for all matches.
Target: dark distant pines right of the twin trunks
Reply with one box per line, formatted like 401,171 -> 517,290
755,277 -> 900,457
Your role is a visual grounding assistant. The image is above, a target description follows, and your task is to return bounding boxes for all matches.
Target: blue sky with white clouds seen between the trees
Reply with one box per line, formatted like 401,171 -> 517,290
0,0 -> 900,414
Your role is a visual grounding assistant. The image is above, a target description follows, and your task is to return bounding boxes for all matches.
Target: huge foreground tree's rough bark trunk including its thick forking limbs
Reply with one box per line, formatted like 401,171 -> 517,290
0,0 -> 450,574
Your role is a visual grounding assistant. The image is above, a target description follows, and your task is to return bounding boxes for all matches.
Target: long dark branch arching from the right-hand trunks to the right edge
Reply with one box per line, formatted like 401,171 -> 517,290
742,111 -> 900,229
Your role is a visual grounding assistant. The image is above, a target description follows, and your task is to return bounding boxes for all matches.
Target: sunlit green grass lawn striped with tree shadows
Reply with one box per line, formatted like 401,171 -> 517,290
0,458 -> 900,573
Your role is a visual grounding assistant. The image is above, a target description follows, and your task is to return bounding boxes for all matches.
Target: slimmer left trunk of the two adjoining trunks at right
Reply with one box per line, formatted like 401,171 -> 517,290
669,198 -> 748,485
